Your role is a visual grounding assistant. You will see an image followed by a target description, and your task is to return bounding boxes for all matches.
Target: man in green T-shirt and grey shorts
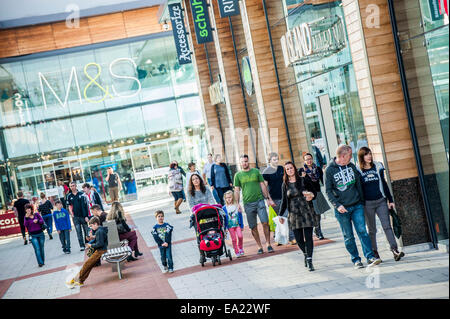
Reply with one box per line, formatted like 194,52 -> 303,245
234,155 -> 275,254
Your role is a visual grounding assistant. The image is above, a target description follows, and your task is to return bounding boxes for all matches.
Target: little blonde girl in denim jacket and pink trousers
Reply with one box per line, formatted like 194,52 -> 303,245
223,190 -> 244,258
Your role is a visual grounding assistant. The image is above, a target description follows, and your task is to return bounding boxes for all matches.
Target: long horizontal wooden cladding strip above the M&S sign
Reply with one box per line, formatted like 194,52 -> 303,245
0,7 -> 163,58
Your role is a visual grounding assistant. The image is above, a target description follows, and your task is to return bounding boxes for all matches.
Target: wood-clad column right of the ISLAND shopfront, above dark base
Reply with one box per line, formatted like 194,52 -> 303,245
358,0 -> 417,180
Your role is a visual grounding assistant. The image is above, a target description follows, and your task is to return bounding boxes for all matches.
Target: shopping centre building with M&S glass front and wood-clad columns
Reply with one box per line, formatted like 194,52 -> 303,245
0,0 -> 449,247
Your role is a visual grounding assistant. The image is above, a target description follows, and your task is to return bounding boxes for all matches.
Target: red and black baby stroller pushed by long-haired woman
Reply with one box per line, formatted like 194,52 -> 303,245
192,204 -> 233,267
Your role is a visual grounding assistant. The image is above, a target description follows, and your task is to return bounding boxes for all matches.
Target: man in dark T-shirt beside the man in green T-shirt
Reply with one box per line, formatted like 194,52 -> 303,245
262,153 -> 297,245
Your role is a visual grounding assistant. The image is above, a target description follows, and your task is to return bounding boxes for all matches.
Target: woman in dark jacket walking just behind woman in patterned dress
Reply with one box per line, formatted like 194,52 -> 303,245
299,153 -> 326,240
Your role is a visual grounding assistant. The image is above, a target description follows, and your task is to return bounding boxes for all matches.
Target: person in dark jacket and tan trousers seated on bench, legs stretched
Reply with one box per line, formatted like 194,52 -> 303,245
67,216 -> 108,288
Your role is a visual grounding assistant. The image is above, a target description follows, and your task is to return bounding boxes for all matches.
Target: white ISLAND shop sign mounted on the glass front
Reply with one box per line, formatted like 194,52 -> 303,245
281,16 -> 346,67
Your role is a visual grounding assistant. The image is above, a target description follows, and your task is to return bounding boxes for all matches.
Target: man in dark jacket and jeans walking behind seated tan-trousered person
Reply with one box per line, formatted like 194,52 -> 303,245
67,182 -> 89,251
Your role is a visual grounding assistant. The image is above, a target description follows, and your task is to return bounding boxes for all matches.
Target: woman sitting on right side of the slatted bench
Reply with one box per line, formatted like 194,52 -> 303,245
106,202 -> 142,261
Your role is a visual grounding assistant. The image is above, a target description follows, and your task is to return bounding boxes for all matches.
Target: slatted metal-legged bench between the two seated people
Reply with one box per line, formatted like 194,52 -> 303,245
102,220 -> 132,279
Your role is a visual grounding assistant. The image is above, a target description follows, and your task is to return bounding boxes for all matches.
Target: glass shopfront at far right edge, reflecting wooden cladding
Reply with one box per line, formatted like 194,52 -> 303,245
393,0 -> 449,241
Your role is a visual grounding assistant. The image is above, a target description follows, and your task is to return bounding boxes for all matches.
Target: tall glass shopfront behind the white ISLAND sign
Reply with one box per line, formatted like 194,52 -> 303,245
285,0 -> 367,162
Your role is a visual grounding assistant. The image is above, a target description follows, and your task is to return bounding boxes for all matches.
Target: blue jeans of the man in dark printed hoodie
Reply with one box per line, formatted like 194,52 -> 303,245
334,204 -> 374,263
